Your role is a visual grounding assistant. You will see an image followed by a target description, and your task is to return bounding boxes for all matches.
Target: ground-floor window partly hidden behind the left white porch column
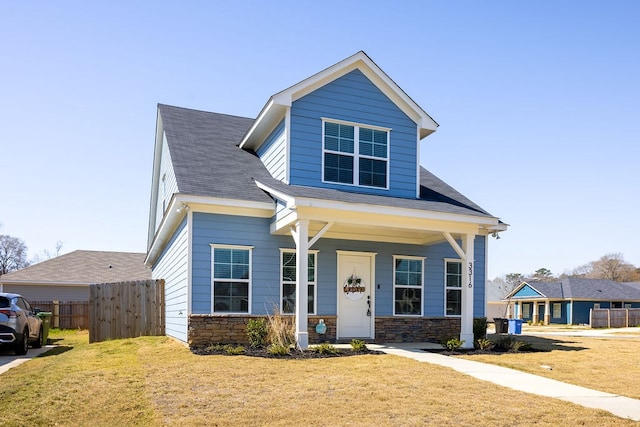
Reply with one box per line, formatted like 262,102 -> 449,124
280,249 -> 318,314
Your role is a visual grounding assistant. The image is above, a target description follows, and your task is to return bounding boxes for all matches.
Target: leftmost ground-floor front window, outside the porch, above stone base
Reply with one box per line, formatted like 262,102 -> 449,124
211,245 -> 252,313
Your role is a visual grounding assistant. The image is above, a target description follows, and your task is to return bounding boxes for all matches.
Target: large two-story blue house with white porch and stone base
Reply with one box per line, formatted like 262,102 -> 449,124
146,52 -> 507,348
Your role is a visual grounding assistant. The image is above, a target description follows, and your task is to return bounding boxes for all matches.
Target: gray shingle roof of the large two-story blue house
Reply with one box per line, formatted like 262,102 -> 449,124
158,104 -> 491,217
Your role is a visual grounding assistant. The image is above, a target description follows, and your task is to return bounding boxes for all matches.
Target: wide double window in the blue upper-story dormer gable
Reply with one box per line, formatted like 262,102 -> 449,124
322,121 -> 390,188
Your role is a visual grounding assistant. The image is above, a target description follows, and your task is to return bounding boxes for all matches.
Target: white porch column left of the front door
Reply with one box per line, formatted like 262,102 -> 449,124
293,219 -> 309,350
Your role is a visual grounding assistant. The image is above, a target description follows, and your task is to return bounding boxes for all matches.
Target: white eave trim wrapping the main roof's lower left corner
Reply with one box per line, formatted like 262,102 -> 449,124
144,194 -> 275,266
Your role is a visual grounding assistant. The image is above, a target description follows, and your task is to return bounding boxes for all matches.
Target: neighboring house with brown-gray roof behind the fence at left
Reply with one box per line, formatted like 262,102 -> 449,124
0,251 -> 151,301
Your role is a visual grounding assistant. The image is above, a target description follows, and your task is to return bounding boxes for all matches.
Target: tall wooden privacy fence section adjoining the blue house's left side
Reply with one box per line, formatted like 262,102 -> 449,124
89,280 -> 165,342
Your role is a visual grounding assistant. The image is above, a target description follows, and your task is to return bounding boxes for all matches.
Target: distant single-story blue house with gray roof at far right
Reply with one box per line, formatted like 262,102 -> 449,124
503,277 -> 640,325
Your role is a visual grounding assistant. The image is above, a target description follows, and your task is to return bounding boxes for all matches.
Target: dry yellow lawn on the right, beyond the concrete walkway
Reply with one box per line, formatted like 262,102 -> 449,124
461,335 -> 640,399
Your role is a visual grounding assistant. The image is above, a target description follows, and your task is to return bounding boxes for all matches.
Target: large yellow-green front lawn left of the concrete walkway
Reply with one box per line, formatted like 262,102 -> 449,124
0,331 -> 635,426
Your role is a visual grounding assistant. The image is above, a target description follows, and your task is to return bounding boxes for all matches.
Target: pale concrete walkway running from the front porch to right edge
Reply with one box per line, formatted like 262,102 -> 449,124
368,343 -> 640,421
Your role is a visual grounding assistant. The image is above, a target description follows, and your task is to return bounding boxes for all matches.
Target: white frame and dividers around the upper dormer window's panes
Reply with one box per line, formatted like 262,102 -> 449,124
321,117 -> 391,190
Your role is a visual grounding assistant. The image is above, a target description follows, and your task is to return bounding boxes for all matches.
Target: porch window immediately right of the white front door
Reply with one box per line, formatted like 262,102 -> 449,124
393,255 -> 424,316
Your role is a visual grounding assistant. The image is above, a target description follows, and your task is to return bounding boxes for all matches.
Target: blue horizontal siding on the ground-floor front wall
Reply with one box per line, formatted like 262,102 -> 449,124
192,213 -> 485,317
